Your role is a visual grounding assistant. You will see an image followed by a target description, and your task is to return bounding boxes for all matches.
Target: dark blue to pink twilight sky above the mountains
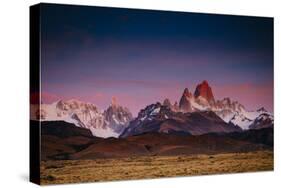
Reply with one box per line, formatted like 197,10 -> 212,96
38,4 -> 273,115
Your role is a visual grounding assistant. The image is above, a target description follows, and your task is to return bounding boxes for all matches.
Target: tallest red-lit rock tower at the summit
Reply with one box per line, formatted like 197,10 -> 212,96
194,80 -> 215,104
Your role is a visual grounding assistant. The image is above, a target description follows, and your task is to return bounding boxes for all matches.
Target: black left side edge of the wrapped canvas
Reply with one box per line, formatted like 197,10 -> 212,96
29,4 -> 41,184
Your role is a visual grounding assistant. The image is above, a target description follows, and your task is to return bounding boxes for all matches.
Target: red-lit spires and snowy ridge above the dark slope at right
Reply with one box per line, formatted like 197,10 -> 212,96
174,81 -> 273,129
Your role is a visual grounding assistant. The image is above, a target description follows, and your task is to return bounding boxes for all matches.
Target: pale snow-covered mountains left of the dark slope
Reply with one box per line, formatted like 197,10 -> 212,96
31,99 -> 132,137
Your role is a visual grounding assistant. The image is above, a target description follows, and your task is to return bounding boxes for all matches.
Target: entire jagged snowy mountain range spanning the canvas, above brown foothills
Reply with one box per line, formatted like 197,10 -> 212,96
31,81 -> 274,138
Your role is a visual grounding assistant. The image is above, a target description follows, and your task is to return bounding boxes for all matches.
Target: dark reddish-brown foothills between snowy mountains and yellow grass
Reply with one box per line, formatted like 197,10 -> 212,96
37,121 -> 273,160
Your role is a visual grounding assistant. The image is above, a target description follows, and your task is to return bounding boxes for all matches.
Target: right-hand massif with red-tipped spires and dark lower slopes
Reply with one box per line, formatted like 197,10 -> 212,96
120,81 -> 273,137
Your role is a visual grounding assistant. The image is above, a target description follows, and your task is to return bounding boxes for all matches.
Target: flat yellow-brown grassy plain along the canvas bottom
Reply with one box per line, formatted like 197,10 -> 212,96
41,151 -> 273,184
